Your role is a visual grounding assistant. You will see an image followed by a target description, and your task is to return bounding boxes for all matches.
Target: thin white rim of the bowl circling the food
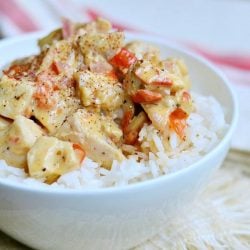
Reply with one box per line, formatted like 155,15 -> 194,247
0,30 -> 239,196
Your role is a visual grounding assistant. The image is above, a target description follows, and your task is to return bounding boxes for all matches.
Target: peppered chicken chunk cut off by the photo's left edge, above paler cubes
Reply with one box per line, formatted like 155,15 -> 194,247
0,76 -> 34,119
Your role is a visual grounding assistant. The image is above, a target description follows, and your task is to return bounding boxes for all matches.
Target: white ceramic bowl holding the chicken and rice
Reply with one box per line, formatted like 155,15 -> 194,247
0,33 -> 238,250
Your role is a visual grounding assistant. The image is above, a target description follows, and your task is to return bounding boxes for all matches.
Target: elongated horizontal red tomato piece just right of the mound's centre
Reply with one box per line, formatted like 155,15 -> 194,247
132,89 -> 162,104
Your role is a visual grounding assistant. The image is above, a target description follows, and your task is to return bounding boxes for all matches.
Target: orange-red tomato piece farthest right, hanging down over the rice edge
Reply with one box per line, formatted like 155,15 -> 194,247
169,108 -> 188,140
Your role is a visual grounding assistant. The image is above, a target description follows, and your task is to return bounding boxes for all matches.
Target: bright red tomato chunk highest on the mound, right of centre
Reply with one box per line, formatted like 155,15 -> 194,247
110,48 -> 137,68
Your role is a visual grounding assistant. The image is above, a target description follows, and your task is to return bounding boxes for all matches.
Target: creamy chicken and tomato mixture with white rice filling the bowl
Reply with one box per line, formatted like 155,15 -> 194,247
0,19 -> 226,188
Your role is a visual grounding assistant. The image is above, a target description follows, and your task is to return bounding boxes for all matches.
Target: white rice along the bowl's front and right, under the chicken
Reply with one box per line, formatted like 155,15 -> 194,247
0,93 -> 227,189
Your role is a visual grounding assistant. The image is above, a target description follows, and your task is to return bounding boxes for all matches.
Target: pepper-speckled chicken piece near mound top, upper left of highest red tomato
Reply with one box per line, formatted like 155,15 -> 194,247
79,32 -> 124,59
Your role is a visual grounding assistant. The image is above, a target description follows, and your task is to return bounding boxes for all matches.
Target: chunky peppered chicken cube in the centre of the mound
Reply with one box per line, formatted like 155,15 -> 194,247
75,70 -> 124,111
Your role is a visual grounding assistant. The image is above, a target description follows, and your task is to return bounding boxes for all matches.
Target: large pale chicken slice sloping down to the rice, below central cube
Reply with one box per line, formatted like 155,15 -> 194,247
56,109 -> 125,168
